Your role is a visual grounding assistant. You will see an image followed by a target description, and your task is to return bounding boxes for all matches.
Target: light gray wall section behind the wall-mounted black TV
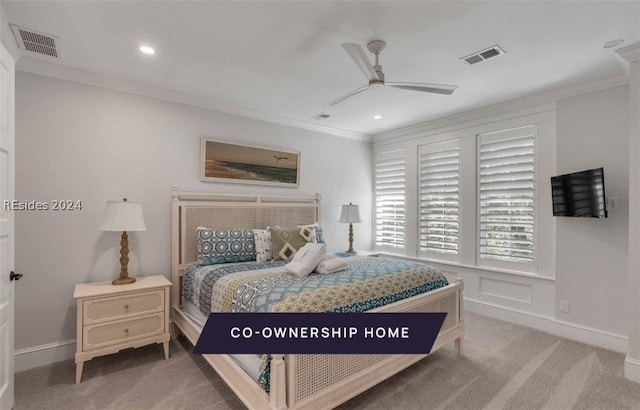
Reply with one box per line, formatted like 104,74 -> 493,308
556,86 -> 637,334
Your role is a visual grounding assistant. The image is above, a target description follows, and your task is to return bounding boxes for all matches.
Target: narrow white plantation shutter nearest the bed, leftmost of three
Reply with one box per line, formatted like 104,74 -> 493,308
375,150 -> 406,252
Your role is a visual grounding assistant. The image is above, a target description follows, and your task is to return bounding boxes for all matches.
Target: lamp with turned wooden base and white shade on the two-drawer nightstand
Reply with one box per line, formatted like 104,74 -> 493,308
100,198 -> 147,285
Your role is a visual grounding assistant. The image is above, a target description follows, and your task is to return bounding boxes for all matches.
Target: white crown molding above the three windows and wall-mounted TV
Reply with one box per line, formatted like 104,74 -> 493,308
372,76 -> 629,145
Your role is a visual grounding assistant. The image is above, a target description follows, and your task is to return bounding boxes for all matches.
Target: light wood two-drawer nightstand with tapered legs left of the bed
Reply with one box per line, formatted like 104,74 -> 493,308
73,275 -> 171,384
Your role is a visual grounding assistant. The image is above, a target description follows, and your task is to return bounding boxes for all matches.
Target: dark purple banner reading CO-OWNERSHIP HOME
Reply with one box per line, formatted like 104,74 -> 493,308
193,313 -> 447,354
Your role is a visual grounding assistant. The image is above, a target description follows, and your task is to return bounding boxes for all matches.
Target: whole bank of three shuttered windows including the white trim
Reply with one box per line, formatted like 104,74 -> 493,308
372,109 -> 556,278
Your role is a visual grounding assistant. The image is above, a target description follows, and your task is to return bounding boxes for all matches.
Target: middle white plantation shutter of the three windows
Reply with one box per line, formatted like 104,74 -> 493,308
419,140 -> 460,255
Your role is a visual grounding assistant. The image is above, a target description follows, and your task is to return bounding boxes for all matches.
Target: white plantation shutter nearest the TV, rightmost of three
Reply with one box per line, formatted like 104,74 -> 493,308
479,127 -> 535,264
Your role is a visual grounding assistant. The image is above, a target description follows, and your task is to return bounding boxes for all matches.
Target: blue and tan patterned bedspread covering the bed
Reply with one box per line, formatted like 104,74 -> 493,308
183,257 -> 449,391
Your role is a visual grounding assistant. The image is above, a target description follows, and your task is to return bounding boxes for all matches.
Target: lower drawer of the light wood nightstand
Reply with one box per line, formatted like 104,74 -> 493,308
82,312 -> 165,351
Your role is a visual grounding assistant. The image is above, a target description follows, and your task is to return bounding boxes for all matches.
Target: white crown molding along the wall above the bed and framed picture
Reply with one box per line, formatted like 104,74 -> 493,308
16,57 -> 371,142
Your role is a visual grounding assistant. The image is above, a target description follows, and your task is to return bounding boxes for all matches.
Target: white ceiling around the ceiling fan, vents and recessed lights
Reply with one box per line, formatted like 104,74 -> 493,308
0,0 -> 640,139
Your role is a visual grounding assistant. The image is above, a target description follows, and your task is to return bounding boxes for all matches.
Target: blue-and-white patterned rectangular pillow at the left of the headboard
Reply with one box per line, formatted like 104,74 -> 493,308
196,226 -> 256,265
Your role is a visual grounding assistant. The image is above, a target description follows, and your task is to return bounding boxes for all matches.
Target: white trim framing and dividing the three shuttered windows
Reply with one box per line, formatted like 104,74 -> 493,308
373,103 -> 556,280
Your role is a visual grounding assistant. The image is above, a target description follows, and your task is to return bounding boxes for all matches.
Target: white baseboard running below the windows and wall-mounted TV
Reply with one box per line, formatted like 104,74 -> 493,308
464,297 -> 628,352
